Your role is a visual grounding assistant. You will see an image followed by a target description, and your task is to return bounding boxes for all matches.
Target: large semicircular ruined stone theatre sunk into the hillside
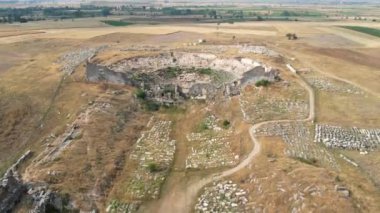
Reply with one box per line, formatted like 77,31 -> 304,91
86,52 -> 278,104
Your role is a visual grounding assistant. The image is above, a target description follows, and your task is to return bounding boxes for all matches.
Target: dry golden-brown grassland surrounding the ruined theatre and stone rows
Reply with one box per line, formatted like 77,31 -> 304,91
0,10 -> 380,212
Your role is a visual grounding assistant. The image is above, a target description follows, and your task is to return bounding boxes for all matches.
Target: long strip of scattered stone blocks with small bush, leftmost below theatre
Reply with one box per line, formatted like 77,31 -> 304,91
127,121 -> 175,199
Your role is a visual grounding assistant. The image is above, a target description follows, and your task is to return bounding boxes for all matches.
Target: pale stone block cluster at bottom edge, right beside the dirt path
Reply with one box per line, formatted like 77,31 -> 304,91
195,181 -> 248,212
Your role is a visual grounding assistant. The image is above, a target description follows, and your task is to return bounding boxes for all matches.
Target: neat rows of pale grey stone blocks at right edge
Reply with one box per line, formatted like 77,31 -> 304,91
315,124 -> 380,150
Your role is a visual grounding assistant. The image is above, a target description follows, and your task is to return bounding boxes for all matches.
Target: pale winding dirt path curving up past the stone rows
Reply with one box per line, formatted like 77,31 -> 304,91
141,65 -> 315,213
